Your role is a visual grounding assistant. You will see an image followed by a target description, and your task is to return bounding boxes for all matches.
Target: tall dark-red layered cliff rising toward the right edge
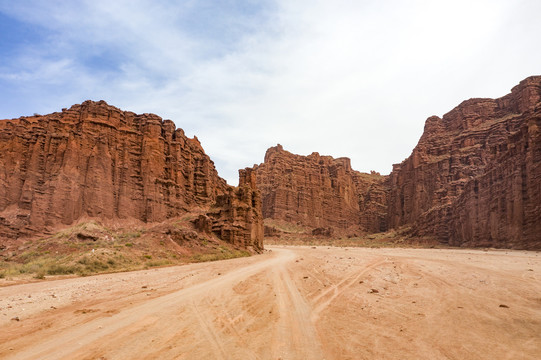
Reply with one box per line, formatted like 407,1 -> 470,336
388,76 -> 541,248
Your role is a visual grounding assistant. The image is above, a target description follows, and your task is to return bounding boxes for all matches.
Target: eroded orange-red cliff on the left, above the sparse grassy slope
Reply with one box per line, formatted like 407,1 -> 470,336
0,101 -> 263,251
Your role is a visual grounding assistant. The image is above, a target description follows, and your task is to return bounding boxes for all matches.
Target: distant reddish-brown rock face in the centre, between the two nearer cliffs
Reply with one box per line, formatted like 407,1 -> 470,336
254,145 -> 387,232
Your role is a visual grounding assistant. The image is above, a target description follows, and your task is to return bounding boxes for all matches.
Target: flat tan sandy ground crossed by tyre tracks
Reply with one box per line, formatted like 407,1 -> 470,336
0,246 -> 541,360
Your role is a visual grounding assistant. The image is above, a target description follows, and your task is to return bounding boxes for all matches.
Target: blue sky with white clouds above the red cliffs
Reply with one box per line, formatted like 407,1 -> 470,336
0,0 -> 541,184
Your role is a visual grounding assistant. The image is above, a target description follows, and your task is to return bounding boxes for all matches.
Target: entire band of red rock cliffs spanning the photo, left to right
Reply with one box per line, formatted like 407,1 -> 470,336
0,76 -> 541,250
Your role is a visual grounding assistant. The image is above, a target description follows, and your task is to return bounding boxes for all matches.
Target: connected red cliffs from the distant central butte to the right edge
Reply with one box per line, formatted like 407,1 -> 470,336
253,76 -> 541,249
